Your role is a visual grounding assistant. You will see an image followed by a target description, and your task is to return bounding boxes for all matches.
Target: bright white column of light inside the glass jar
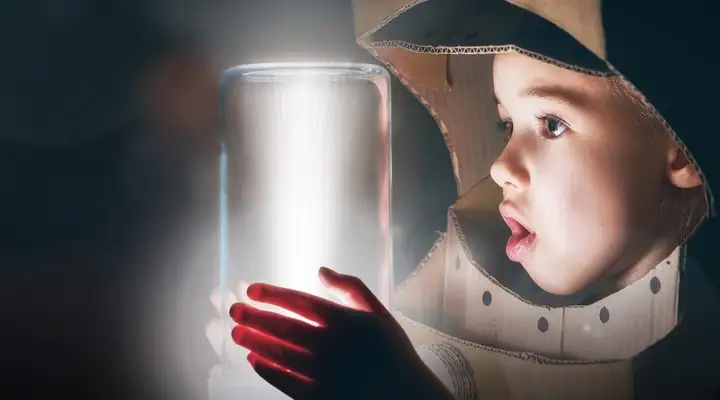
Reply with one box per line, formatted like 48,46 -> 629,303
258,80 -> 342,295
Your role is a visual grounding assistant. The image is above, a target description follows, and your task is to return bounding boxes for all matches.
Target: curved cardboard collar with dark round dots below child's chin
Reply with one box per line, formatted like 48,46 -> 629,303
450,203 -> 685,359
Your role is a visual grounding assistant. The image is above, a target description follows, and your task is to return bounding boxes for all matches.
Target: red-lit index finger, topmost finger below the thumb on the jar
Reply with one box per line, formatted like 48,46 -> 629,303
247,283 -> 340,325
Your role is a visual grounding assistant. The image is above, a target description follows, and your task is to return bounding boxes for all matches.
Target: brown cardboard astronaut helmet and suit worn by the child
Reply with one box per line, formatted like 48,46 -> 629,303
353,0 -> 720,399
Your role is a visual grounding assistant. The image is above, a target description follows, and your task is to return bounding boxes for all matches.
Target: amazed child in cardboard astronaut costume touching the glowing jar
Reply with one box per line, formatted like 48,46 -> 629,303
222,0 -> 720,399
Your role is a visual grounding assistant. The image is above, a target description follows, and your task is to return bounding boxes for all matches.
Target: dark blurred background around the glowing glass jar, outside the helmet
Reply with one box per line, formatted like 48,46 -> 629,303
0,0 -> 455,399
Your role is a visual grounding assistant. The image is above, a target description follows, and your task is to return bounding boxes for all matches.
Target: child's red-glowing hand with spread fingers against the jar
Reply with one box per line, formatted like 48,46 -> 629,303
230,268 -> 452,400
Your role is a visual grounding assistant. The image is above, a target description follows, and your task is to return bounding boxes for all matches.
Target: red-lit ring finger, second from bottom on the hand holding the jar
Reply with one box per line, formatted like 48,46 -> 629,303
232,325 -> 313,377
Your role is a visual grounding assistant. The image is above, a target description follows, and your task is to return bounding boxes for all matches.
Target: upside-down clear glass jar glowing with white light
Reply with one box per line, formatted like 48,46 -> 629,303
211,63 -> 393,400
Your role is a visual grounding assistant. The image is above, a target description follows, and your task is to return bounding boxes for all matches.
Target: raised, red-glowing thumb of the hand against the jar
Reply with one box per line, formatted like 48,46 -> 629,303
318,267 -> 389,315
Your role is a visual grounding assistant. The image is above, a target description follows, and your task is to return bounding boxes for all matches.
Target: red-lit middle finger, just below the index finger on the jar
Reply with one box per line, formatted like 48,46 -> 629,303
230,303 -> 324,351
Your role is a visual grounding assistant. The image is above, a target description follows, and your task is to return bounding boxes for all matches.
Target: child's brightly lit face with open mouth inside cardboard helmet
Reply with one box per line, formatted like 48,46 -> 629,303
491,53 -> 667,294
